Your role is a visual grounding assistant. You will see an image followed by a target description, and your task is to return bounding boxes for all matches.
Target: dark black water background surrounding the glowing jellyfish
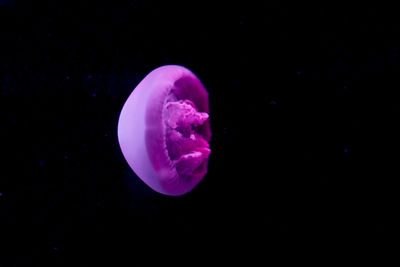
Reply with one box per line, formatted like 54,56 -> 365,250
0,0 -> 400,266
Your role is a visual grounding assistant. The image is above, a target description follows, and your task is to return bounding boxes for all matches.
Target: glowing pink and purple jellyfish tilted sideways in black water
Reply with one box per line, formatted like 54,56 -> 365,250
118,65 -> 211,196
